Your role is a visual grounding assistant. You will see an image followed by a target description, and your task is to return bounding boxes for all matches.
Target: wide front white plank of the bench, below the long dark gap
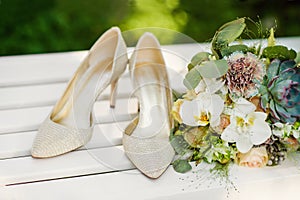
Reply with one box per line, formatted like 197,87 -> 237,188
2,161 -> 300,200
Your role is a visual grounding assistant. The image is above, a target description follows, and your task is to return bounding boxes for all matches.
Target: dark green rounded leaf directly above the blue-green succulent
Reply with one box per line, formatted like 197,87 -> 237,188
262,45 -> 297,60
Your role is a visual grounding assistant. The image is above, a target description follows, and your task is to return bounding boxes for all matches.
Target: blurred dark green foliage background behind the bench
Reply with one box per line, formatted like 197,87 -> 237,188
0,0 -> 300,55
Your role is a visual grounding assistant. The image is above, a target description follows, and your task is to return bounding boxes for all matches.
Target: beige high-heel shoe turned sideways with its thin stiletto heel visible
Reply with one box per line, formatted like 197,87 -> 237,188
31,27 -> 128,158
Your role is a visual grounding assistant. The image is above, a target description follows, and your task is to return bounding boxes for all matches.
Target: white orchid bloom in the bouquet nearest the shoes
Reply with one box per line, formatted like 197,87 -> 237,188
179,92 -> 224,126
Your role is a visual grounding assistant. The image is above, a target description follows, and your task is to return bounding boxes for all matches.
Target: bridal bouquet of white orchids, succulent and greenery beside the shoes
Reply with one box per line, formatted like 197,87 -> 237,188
170,18 -> 300,173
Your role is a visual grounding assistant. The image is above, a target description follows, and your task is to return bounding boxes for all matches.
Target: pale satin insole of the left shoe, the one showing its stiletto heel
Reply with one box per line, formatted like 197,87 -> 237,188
52,40 -> 116,129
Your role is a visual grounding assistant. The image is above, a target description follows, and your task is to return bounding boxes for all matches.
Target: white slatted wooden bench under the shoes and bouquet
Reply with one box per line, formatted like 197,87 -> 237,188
0,37 -> 300,200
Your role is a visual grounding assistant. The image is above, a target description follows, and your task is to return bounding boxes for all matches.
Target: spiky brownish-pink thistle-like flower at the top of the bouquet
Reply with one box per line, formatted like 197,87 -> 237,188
226,52 -> 264,98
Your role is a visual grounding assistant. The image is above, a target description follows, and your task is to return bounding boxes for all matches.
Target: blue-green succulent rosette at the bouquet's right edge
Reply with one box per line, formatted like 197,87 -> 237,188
260,59 -> 300,123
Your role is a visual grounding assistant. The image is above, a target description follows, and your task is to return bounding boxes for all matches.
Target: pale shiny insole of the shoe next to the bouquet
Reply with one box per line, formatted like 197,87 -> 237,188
132,63 -> 170,138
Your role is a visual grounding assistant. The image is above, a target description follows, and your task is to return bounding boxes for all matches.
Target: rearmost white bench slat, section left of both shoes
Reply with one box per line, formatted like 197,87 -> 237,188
0,51 -> 87,87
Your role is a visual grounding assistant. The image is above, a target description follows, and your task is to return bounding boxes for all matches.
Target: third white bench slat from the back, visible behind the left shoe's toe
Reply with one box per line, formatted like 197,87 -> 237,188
0,98 -> 137,134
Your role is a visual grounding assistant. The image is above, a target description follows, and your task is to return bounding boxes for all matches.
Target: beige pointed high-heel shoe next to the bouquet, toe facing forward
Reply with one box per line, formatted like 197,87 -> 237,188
123,33 -> 175,178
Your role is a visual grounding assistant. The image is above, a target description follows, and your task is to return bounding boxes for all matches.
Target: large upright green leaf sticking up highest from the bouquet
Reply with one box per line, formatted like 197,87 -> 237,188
212,18 -> 246,58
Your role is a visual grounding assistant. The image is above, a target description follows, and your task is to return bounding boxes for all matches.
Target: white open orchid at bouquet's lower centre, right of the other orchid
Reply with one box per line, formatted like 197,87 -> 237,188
221,109 -> 272,153
